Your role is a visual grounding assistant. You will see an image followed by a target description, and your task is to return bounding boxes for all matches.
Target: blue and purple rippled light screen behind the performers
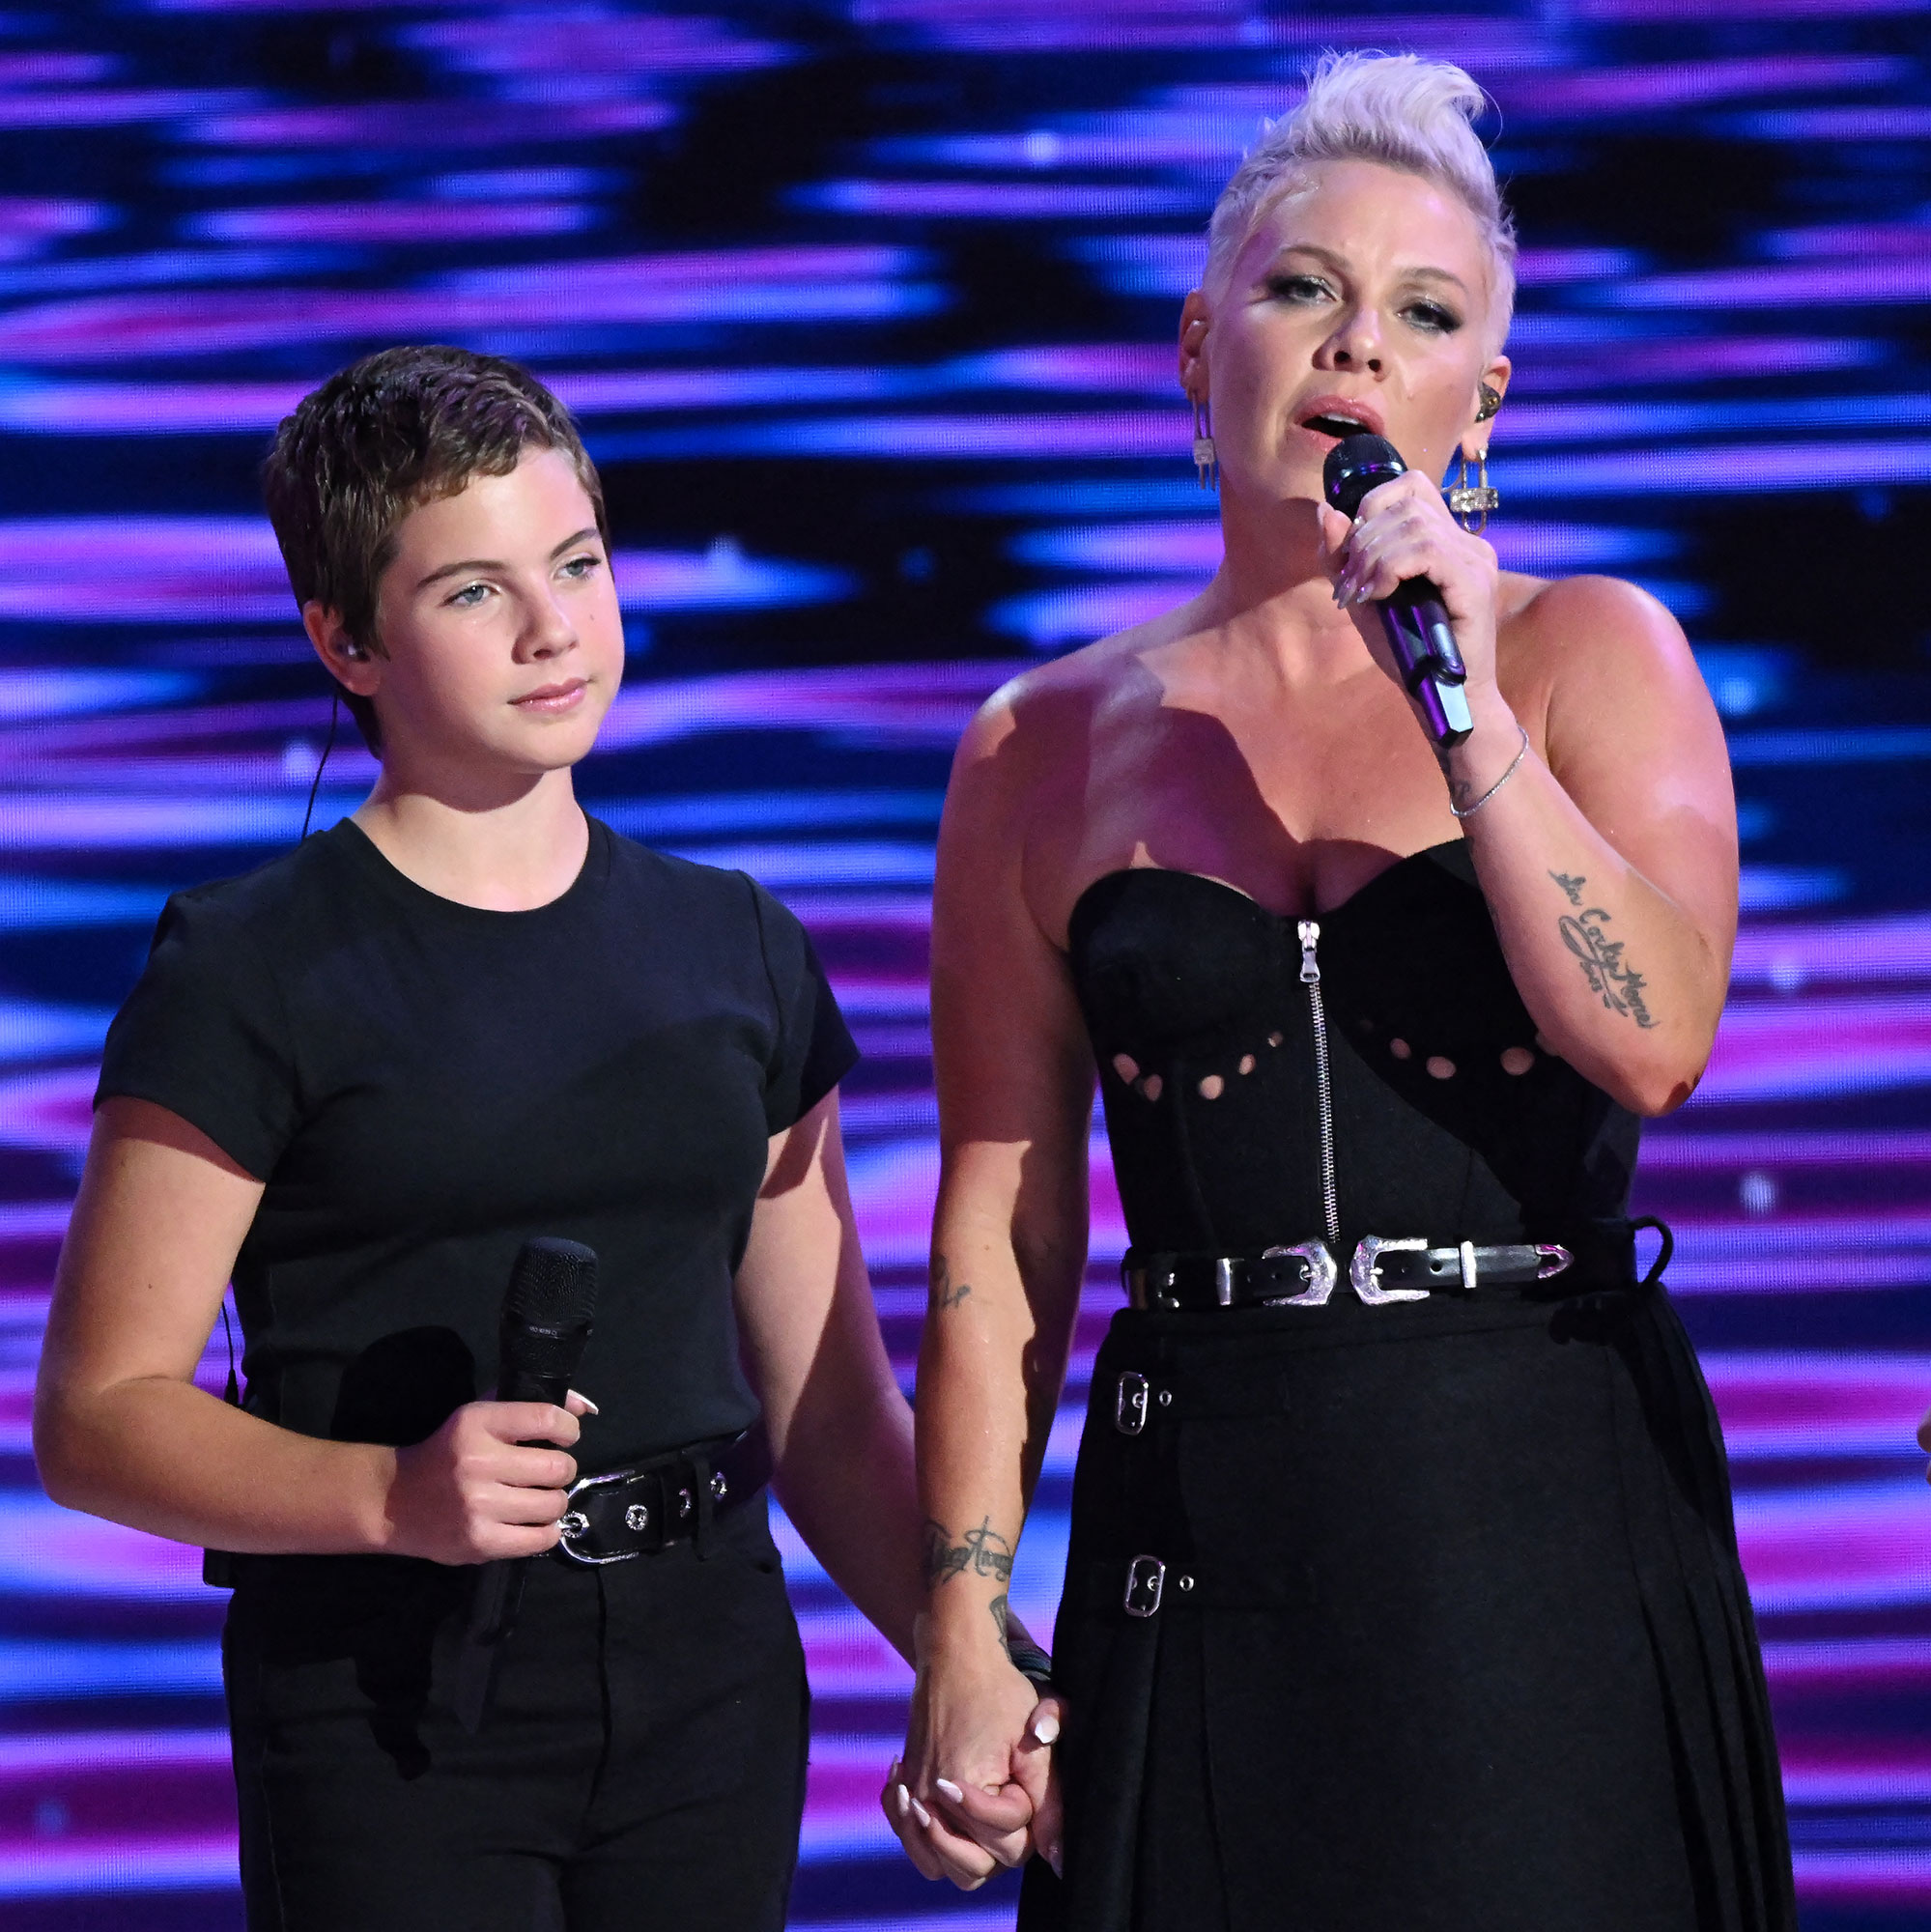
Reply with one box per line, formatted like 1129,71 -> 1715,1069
0,0 -> 1931,1932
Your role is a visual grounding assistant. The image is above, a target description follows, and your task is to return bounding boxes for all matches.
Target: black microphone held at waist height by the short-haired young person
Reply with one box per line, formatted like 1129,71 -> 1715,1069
456,1235 -> 597,1733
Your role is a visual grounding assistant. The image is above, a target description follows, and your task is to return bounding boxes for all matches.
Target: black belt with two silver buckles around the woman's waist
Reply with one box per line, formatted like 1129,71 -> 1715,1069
1120,1235 -> 1633,1310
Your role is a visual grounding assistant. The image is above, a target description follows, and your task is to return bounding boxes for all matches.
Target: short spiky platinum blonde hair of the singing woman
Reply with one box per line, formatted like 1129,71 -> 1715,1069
1201,54 -> 1516,348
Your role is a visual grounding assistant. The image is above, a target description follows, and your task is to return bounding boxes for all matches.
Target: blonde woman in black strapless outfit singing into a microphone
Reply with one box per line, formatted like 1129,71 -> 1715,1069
885,45 -> 1796,1932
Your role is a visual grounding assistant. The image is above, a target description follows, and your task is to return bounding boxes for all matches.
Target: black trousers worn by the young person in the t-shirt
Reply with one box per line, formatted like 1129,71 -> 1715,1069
222,1501 -> 809,1932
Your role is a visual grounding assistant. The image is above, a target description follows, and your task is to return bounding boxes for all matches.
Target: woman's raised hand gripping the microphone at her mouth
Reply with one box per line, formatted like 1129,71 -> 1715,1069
1320,469 -> 1498,699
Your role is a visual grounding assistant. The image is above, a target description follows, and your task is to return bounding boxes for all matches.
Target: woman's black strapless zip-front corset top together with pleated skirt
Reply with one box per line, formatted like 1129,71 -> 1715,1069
1019,842 -> 1796,1932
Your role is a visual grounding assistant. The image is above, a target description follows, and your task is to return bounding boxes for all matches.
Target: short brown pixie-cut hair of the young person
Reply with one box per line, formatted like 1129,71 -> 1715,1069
263,348 -> 611,755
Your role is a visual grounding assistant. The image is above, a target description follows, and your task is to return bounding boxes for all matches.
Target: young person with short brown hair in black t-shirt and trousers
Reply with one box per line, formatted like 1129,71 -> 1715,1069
35,348 -> 920,1932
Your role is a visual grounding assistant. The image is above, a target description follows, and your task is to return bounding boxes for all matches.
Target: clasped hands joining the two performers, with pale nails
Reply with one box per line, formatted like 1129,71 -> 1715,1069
879,1617 -> 1064,1891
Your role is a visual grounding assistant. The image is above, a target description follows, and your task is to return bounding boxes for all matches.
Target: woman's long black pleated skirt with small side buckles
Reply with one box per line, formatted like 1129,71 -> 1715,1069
1019,1287 -> 1796,1932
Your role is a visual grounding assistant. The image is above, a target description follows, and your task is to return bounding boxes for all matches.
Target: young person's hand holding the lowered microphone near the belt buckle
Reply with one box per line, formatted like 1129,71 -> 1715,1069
384,1389 -> 597,1563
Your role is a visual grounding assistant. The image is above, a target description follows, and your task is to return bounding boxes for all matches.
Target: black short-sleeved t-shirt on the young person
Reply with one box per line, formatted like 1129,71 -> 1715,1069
97,819 -> 858,1470
